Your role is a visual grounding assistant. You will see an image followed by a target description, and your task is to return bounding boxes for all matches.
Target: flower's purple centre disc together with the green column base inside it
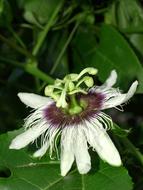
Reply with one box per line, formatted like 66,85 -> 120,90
44,93 -> 104,127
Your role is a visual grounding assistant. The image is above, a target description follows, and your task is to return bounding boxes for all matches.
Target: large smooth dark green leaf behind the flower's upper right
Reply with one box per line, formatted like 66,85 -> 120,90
74,25 -> 143,93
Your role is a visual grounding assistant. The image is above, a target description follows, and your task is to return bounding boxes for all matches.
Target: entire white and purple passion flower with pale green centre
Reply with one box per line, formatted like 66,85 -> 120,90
10,68 -> 138,176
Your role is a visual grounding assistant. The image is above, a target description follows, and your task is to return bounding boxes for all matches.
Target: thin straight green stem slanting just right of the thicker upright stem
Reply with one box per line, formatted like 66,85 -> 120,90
50,22 -> 79,75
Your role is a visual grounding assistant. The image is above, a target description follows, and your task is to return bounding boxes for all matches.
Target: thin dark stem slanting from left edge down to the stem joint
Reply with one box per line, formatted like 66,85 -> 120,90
0,34 -> 35,60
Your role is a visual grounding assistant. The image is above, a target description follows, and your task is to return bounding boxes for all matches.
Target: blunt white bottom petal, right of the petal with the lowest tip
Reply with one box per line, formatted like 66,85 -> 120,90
74,126 -> 91,174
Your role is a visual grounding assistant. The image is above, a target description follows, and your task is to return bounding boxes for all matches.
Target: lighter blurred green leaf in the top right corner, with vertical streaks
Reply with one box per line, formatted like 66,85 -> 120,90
104,0 -> 143,32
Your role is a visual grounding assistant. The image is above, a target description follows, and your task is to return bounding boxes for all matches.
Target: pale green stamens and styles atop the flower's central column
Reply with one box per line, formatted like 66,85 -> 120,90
45,67 -> 97,108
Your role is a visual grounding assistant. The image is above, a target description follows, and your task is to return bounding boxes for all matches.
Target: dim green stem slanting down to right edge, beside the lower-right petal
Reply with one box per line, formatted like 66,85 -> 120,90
120,138 -> 143,165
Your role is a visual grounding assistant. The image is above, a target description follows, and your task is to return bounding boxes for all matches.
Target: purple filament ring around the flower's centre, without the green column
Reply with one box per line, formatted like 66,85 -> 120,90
43,92 -> 105,127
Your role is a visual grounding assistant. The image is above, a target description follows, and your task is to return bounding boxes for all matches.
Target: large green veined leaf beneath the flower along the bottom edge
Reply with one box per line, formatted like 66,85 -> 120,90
0,130 -> 132,190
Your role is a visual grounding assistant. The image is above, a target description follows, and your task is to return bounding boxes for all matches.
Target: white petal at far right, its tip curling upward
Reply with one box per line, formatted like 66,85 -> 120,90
102,81 -> 138,109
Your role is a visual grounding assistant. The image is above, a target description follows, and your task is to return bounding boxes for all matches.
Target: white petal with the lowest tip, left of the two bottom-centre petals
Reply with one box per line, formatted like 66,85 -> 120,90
61,126 -> 74,176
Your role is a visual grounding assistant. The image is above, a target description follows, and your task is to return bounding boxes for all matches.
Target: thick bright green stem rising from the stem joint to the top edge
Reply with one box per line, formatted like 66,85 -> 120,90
32,0 -> 63,56
